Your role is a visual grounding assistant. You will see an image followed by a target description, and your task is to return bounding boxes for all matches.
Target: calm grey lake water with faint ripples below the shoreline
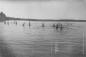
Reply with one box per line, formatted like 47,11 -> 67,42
0,21 -> 86,57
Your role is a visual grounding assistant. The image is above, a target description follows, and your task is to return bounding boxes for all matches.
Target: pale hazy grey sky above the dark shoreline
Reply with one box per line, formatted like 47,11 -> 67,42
0,0 -> 86,19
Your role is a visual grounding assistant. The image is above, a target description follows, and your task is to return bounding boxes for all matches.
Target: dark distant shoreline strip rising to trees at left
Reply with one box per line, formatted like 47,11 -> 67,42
0,12 -> 86,22
